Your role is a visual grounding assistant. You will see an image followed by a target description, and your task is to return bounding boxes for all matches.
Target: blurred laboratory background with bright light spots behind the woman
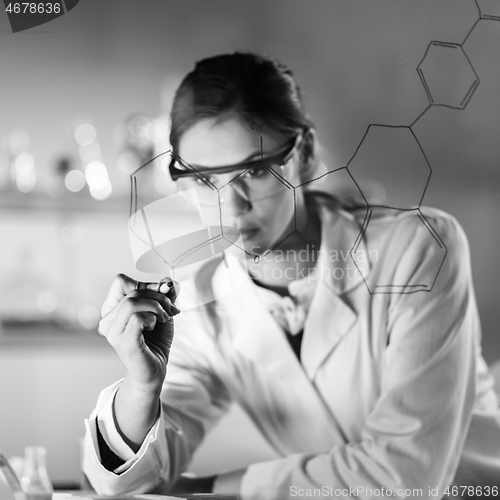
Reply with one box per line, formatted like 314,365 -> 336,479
0,0 -> 500,488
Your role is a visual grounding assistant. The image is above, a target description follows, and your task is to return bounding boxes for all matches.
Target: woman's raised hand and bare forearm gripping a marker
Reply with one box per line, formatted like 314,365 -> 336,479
99,274 -> 180,452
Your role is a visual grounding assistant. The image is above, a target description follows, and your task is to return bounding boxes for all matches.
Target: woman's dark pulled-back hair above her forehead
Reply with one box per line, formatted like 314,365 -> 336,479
170,52 -> 313,151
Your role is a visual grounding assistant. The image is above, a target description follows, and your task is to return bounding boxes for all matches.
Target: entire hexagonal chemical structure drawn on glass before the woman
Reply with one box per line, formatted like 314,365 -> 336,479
129,0 -> 500,295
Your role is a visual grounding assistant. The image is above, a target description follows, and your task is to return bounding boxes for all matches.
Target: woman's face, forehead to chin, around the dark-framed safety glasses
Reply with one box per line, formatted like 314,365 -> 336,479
178,117 -> 300,255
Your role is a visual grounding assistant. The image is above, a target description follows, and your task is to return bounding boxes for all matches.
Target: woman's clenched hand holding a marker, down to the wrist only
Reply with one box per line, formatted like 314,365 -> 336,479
99,274 -> 180,391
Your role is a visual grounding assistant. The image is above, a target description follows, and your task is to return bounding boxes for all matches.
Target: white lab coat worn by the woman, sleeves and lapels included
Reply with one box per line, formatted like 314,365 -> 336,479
84,204 -> 500,500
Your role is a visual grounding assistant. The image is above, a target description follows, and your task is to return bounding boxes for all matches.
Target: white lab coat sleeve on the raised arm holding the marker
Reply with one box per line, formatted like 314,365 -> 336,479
83,313 -> 230,495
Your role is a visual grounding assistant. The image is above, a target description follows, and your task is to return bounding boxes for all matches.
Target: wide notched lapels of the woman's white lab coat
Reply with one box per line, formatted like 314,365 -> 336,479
214,203 -> 370,382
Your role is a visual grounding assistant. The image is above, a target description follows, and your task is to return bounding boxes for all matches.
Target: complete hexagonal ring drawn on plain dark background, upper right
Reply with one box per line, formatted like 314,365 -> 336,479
417,41 -> 480,109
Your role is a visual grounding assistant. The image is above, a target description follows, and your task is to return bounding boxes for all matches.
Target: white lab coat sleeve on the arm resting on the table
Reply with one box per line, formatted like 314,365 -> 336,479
241,216 -> 480,500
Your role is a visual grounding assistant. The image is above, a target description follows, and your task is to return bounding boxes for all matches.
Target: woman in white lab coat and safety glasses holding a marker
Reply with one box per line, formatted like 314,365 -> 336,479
84,53 -> 500,499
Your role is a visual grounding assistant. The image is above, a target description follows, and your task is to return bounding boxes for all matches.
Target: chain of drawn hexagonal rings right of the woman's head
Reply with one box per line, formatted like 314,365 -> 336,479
346,0 -> 500,294
